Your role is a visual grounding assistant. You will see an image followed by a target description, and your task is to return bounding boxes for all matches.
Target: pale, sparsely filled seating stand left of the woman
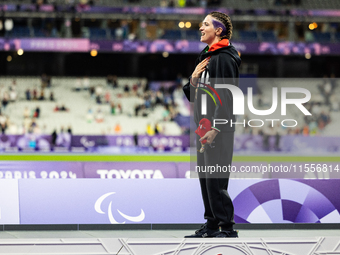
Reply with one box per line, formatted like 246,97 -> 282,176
0,77 -> 189,135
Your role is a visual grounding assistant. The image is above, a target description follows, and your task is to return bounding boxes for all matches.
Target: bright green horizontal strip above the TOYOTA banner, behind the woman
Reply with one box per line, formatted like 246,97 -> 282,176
0,154 -> 340,163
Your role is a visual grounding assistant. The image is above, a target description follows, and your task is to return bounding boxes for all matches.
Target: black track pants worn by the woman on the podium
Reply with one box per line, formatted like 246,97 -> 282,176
197,132 -> 235,230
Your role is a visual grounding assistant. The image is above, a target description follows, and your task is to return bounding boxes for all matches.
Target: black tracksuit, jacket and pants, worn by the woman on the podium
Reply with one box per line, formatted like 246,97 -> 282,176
183,41 -> 241,230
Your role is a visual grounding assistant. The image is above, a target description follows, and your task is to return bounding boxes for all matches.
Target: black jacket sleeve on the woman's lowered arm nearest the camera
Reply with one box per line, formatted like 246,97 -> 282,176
210,53 -> 239,126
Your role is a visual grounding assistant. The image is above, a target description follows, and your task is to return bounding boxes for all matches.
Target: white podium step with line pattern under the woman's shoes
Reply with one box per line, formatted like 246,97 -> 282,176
0,235 -> 340,255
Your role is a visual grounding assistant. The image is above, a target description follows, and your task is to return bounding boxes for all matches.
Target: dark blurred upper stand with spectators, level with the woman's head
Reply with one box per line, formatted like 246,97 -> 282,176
0,0 -> 340,43
